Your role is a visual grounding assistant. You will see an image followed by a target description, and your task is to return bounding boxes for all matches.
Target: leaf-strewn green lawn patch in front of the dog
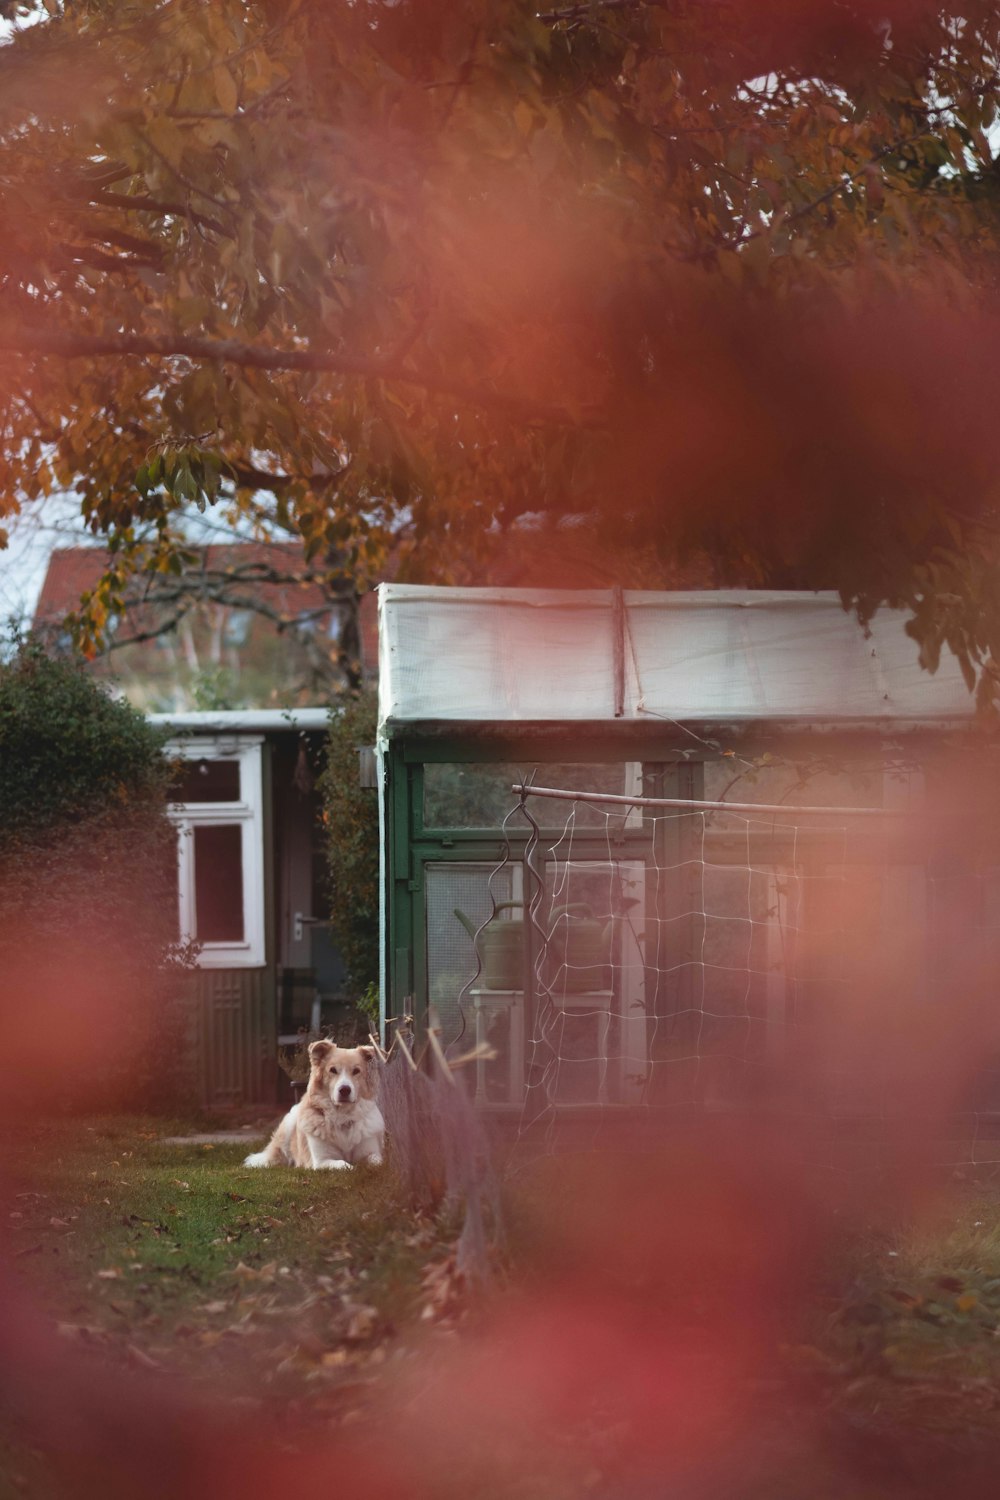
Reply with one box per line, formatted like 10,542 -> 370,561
3,1119 -> 454,1412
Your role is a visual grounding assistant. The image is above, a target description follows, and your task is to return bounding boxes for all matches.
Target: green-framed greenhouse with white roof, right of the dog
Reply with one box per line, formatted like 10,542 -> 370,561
378,584 -> 1000,1113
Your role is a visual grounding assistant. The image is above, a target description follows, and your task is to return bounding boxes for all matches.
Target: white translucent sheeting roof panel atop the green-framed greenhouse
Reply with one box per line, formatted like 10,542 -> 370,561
378,584 -> 975,731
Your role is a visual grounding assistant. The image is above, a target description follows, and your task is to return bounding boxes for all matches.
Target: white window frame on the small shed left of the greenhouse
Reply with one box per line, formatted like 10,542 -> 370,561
166,735 -> 264,969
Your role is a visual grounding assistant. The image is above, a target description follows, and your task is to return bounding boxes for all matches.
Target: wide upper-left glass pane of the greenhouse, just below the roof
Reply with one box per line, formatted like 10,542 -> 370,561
424,761 -> 640,831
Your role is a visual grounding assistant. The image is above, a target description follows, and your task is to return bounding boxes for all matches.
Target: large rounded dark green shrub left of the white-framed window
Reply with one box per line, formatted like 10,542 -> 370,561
0,641 -> 190,1107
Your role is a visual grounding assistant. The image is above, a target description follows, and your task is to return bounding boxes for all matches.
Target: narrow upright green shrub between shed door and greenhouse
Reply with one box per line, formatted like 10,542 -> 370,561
319,692 -> 378,1002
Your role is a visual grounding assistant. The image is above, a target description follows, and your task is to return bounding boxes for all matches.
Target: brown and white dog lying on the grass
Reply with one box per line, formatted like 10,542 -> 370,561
243,1041 -> 385,1172
